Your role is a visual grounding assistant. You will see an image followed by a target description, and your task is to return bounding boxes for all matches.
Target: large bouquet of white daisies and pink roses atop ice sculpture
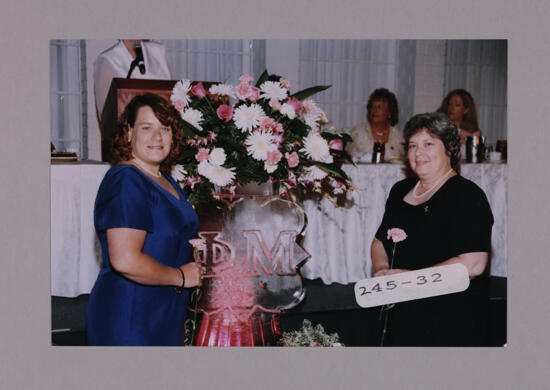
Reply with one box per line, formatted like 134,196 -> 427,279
170,71 -> 352,209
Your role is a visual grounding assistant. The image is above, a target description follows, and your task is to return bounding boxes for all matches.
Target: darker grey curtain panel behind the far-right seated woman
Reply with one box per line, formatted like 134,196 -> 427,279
445,40 -> 508,145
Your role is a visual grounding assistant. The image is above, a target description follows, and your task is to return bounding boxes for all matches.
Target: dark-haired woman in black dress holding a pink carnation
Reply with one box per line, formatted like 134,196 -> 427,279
371,113 -> 493,346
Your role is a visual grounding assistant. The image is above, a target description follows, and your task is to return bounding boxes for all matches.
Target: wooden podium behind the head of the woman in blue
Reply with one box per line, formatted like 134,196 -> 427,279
101,78 -> 178,162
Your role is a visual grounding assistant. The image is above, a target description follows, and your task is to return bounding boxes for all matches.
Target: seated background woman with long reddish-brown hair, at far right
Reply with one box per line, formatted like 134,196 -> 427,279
437,89 -> 482,159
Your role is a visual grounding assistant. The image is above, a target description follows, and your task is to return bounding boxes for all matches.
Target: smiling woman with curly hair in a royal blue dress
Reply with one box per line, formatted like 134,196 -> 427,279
87,94 -> 204,345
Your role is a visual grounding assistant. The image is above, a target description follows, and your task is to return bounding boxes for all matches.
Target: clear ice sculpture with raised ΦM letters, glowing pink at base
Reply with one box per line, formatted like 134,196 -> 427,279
188,183 -> 309,346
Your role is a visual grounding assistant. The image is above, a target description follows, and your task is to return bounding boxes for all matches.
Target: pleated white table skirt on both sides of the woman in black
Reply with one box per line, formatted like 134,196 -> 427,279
302,164 -> 508,284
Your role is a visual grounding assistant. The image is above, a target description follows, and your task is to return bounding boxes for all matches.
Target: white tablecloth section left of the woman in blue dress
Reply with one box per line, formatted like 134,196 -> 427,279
51,162 -> 109,297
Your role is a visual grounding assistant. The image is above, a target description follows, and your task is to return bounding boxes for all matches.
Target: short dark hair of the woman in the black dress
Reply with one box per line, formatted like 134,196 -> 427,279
403,112 -> 460,172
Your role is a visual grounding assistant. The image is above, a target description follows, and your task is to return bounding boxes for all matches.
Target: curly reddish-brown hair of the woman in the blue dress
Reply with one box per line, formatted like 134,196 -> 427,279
110,93 -> 183,173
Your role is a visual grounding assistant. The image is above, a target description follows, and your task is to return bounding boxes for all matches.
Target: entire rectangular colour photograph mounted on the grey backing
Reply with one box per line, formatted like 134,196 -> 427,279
49,39 -> 508,349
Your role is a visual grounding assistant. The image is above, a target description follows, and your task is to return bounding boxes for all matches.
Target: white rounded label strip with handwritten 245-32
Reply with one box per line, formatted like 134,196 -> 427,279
355,263 -> 470,307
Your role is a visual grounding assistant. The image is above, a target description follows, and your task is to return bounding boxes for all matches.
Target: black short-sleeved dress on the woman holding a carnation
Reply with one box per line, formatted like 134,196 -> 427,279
376,175 -> 493,346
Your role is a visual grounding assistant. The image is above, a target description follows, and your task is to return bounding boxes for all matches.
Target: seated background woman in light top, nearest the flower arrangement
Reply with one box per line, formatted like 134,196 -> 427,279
346,88 -> 403,160
